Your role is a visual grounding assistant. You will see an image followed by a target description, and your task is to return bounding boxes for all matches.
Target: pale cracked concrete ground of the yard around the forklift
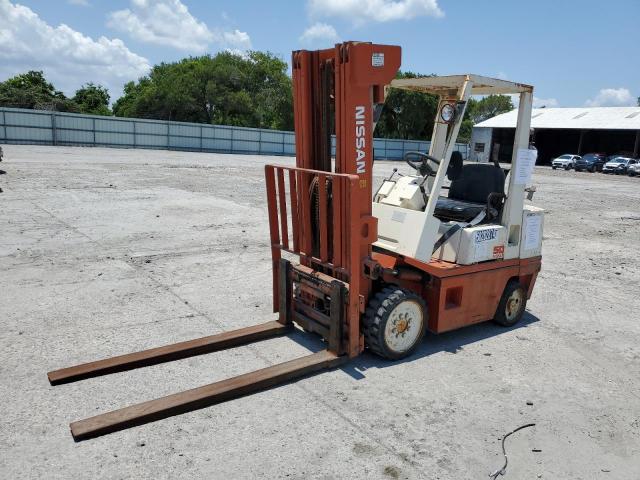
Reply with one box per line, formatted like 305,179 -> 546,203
0,146 -> 640,480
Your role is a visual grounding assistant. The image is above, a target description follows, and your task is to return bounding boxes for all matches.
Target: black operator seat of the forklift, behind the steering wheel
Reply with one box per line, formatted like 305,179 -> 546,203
434,159 -> 505,222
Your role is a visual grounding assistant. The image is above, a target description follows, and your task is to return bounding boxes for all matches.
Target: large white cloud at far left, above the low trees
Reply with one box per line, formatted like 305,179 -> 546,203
0,0 -> 150,99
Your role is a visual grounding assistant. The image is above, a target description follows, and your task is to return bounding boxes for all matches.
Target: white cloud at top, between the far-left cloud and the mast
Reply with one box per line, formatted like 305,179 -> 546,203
107,0 -> 251,53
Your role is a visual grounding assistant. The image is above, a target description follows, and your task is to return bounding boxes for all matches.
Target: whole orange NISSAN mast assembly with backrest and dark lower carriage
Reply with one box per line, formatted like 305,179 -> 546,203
265,42 -> 400,356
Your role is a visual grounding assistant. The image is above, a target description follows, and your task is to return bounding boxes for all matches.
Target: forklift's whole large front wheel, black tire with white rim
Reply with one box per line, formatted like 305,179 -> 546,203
363,285 -> 428,360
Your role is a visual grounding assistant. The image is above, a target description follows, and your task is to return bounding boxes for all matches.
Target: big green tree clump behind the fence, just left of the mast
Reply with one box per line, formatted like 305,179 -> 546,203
113,52 -> 293,130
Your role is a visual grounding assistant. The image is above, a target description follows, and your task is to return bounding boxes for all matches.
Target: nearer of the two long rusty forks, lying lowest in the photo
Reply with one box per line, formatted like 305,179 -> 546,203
71,348 -> 348,441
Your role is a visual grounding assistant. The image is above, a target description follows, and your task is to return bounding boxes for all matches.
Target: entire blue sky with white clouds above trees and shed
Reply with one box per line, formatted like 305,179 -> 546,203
0,0 -> 640,107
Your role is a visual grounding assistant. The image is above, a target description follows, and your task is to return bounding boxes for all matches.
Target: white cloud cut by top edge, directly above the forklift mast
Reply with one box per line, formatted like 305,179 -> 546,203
308,0 -> 444,25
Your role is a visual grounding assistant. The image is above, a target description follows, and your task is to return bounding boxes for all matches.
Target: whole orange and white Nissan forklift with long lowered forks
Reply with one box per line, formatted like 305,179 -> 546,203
48,42 -> 543,441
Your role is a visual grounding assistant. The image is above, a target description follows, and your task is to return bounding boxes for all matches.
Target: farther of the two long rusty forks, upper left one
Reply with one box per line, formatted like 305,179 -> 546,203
47,321 -> 291,385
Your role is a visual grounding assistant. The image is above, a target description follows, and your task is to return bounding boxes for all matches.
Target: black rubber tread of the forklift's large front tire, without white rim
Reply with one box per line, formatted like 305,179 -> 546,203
363,285 -> 428,360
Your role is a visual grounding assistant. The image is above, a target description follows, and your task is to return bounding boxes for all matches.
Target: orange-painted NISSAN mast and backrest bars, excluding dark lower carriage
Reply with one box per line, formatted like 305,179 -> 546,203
276,42 -> 401,357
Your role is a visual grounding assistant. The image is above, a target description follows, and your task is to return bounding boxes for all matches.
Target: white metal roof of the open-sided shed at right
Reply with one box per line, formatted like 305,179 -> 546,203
476,107 -> 640,130
